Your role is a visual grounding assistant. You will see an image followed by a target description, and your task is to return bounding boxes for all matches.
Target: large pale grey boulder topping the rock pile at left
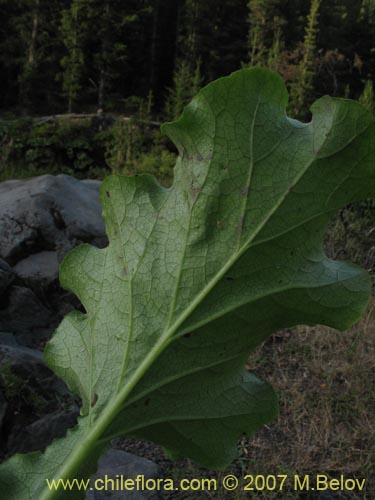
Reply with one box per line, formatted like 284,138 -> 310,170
0,175 -> 106,265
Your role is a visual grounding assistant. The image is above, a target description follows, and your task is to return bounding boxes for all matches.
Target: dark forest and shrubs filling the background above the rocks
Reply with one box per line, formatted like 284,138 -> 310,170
0,0 -> 375,184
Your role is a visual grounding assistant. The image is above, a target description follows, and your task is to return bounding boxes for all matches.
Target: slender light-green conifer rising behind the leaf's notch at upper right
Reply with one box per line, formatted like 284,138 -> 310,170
290,0 -> 320,118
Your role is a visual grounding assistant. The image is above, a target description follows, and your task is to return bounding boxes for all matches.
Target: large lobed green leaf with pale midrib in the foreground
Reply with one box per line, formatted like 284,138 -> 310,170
0,69 -> 375,500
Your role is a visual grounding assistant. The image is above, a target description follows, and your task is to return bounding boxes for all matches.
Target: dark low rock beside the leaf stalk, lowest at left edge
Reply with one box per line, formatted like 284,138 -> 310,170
7,407 -> 79,455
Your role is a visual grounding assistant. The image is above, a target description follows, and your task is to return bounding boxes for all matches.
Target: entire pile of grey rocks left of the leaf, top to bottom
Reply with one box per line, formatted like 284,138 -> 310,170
0,175 -> 107,457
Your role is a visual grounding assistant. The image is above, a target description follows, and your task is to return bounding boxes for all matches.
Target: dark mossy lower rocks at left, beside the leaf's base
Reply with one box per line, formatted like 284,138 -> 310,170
0,333 -> 79,456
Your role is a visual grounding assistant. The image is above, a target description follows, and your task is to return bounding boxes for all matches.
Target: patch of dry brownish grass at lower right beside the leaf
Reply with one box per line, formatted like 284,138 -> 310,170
239,304 -> 375,499
